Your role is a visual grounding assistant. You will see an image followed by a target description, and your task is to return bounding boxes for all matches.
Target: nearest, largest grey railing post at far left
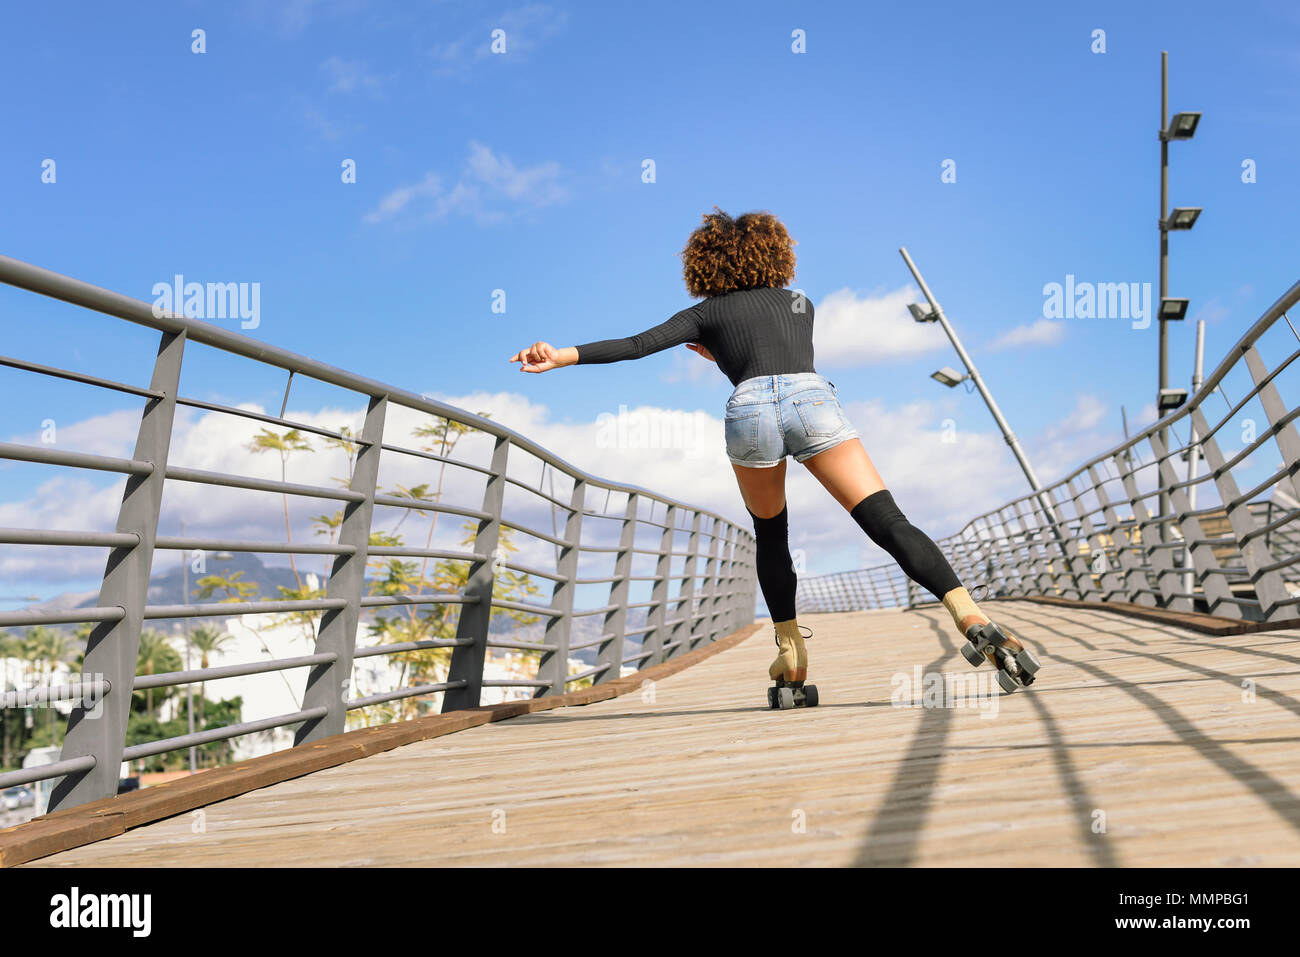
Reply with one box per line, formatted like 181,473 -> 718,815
48,332 -> 185,811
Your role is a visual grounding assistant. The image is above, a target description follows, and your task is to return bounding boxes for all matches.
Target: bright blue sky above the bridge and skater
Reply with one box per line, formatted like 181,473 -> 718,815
0,0 -> 1300,605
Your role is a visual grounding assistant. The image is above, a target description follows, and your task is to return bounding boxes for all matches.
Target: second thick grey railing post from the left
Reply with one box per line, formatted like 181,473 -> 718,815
294,395 -> 389,746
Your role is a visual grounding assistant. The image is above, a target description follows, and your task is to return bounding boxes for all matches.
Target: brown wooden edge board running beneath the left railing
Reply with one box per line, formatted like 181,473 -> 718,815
0,622 -> 763,867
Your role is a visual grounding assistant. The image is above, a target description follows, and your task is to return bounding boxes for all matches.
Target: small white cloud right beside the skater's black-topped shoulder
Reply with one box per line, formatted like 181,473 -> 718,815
813,286 -> 948,367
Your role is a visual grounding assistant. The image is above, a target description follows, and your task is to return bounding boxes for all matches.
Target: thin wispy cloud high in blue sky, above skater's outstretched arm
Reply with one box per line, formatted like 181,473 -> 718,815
364,140 -> 569,225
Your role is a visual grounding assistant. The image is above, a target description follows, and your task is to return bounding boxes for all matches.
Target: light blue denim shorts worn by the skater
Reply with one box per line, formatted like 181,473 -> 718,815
724,372 -> 858,468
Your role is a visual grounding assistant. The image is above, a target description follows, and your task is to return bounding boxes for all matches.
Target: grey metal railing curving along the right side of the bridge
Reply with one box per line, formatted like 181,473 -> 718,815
798,282 -> 1300,622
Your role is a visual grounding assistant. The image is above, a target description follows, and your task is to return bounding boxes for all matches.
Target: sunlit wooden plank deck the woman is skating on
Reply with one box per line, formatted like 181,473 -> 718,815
20,602 -> 1300,867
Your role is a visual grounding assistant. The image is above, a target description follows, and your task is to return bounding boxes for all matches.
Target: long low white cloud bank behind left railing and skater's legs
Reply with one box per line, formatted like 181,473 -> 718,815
0,382 -> 1138,592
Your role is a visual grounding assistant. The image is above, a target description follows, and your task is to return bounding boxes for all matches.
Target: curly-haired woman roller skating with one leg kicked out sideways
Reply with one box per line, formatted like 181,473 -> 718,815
510,207 -> 1039,707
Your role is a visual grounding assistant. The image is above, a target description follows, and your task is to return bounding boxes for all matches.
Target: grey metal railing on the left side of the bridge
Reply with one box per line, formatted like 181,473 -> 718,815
0,256 -> 757,810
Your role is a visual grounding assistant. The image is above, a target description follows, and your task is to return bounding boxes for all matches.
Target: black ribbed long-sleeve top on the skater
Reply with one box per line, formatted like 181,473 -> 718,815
577,287 -> 816,385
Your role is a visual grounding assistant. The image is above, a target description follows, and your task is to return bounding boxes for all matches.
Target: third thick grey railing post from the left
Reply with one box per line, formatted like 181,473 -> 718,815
442,436 -> 510,713
